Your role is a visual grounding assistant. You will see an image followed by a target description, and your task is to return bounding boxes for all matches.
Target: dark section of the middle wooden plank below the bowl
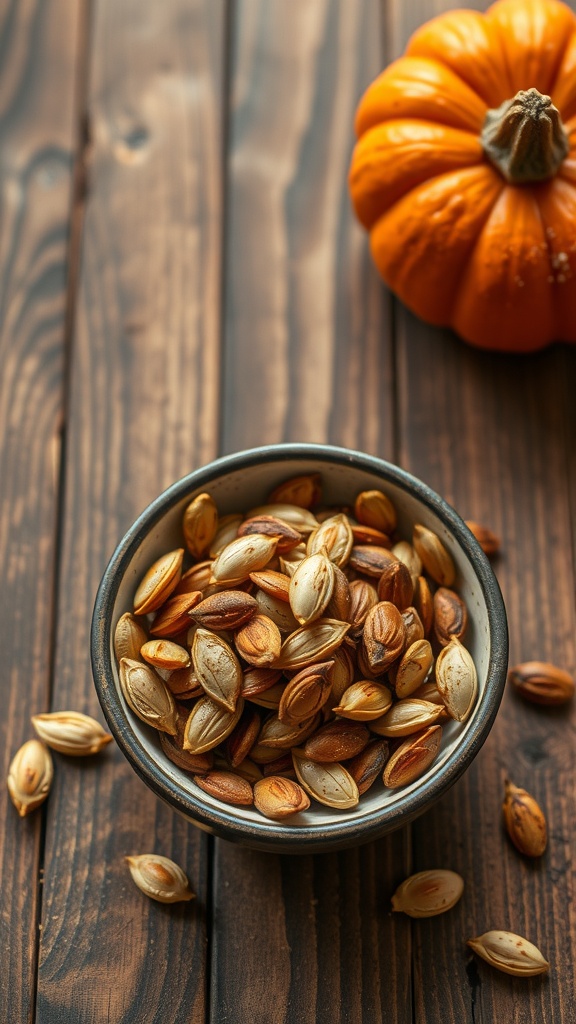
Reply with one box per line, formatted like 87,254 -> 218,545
211,830 -> 412,1024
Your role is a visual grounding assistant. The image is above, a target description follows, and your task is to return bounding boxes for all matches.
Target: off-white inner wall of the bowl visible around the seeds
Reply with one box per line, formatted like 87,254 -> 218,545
111,459 -> 490,830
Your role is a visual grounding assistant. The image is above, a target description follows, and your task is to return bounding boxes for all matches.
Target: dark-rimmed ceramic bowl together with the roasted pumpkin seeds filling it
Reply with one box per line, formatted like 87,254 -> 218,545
91,444 -> 507,853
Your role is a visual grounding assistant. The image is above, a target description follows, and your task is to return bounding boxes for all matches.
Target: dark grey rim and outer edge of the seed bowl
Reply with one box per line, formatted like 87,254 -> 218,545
90,443 -> 508,853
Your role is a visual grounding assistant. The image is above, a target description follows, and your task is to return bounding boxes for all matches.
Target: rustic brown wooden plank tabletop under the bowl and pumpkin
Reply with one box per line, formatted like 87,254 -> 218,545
0,0 -> 576,1024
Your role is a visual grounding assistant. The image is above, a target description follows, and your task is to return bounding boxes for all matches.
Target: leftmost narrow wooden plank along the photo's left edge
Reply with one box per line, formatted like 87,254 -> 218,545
0,0 -> 82,1022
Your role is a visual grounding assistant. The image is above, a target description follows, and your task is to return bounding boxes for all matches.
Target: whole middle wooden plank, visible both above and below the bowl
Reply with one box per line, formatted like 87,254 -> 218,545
211,0 -> 411,1024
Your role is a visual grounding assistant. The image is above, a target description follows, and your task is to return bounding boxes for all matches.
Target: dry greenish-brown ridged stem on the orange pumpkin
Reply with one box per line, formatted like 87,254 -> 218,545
481,89 -> 570,184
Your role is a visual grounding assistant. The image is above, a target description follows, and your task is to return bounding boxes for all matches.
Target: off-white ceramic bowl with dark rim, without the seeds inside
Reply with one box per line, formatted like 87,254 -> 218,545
91,444 -> 507,853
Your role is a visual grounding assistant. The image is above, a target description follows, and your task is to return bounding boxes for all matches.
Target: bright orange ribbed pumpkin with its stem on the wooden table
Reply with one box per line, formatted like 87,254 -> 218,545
349,0 -> 576,351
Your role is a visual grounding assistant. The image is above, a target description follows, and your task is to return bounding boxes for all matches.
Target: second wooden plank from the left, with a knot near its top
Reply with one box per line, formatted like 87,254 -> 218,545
38,0 -> 225,1024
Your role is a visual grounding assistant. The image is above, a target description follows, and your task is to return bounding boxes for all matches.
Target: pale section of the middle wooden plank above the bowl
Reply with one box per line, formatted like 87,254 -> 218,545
222,0 -> 392,452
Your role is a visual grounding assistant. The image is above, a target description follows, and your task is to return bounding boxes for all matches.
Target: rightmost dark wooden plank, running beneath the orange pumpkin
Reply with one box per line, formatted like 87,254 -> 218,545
385,3 -> 576,1024
